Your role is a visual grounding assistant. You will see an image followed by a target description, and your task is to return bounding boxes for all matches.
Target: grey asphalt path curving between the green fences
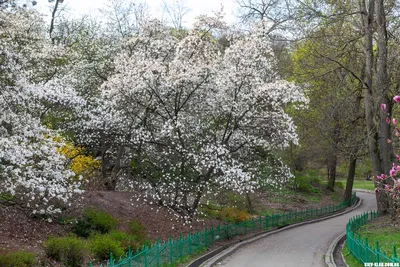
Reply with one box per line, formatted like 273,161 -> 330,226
217,192 -> 376,267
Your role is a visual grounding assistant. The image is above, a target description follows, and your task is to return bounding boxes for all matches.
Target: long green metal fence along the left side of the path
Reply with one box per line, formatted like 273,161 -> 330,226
90,192 -> 356,267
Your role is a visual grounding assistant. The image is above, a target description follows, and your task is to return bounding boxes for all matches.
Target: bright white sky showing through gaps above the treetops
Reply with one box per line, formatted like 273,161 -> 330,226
37,0 -> 236,27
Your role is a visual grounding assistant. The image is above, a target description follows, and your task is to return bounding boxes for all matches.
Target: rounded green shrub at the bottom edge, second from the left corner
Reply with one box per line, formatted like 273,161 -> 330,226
43,236 -> 87,267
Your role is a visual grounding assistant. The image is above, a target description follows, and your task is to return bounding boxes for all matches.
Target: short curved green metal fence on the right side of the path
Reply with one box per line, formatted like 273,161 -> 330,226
346,211 -> 400,266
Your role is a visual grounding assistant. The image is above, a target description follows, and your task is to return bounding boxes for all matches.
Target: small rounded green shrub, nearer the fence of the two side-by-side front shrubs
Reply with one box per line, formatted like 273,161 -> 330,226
90,235 -> 124,260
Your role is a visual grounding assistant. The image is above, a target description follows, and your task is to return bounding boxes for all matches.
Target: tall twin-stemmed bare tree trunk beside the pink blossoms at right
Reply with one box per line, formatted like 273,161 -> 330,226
359,0 -> 391,214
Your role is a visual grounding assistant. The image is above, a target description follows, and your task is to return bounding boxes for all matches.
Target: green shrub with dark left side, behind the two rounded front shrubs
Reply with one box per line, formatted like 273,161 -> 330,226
74,208 -> 118,238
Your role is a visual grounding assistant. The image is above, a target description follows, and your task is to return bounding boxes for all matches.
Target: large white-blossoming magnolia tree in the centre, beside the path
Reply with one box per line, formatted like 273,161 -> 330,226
82,15 -> 306,217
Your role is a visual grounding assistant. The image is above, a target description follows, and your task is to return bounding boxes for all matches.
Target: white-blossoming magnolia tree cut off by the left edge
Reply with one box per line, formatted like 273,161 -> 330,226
0,9 -> 83,217
